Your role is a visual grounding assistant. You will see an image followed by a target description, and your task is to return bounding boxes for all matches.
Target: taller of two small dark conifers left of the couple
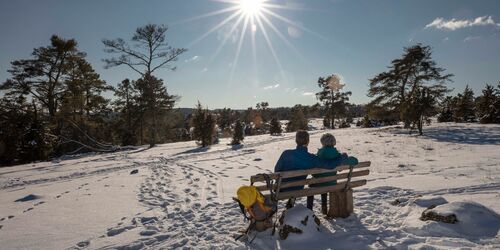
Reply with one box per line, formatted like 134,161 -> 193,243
191,102 -> 216,147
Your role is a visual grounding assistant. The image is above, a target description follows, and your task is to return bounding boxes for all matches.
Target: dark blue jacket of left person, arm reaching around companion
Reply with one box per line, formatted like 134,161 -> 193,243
274,146 -> 348,192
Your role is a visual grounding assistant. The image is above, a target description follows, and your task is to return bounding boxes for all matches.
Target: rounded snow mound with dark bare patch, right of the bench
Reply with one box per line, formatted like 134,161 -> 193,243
406,202 -> 500,238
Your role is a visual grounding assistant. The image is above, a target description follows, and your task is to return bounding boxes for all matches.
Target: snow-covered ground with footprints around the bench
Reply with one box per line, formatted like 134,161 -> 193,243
0,120 -> 500,249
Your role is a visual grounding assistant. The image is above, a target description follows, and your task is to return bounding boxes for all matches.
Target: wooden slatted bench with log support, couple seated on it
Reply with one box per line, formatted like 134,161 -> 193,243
250,161 -> 370,218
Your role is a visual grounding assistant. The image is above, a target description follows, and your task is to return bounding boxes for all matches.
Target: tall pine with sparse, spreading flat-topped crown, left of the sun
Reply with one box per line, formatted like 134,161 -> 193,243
102,24 -> 187,147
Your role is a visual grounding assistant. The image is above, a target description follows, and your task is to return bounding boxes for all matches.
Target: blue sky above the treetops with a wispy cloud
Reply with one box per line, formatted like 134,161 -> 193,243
0,0 -> 500,108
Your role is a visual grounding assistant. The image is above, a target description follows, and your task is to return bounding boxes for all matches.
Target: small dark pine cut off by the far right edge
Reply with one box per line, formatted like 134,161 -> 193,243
476,84 -> 499,123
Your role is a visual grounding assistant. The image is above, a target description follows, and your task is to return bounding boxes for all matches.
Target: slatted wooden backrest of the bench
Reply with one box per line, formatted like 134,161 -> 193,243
250,161 -> 371,200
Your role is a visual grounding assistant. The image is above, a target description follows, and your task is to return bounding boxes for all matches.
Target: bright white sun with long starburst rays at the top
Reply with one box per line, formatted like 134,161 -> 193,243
182,0 -> 327,84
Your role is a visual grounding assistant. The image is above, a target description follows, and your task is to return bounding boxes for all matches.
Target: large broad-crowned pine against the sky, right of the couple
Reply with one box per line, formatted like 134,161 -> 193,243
367,44 -> 453,127
